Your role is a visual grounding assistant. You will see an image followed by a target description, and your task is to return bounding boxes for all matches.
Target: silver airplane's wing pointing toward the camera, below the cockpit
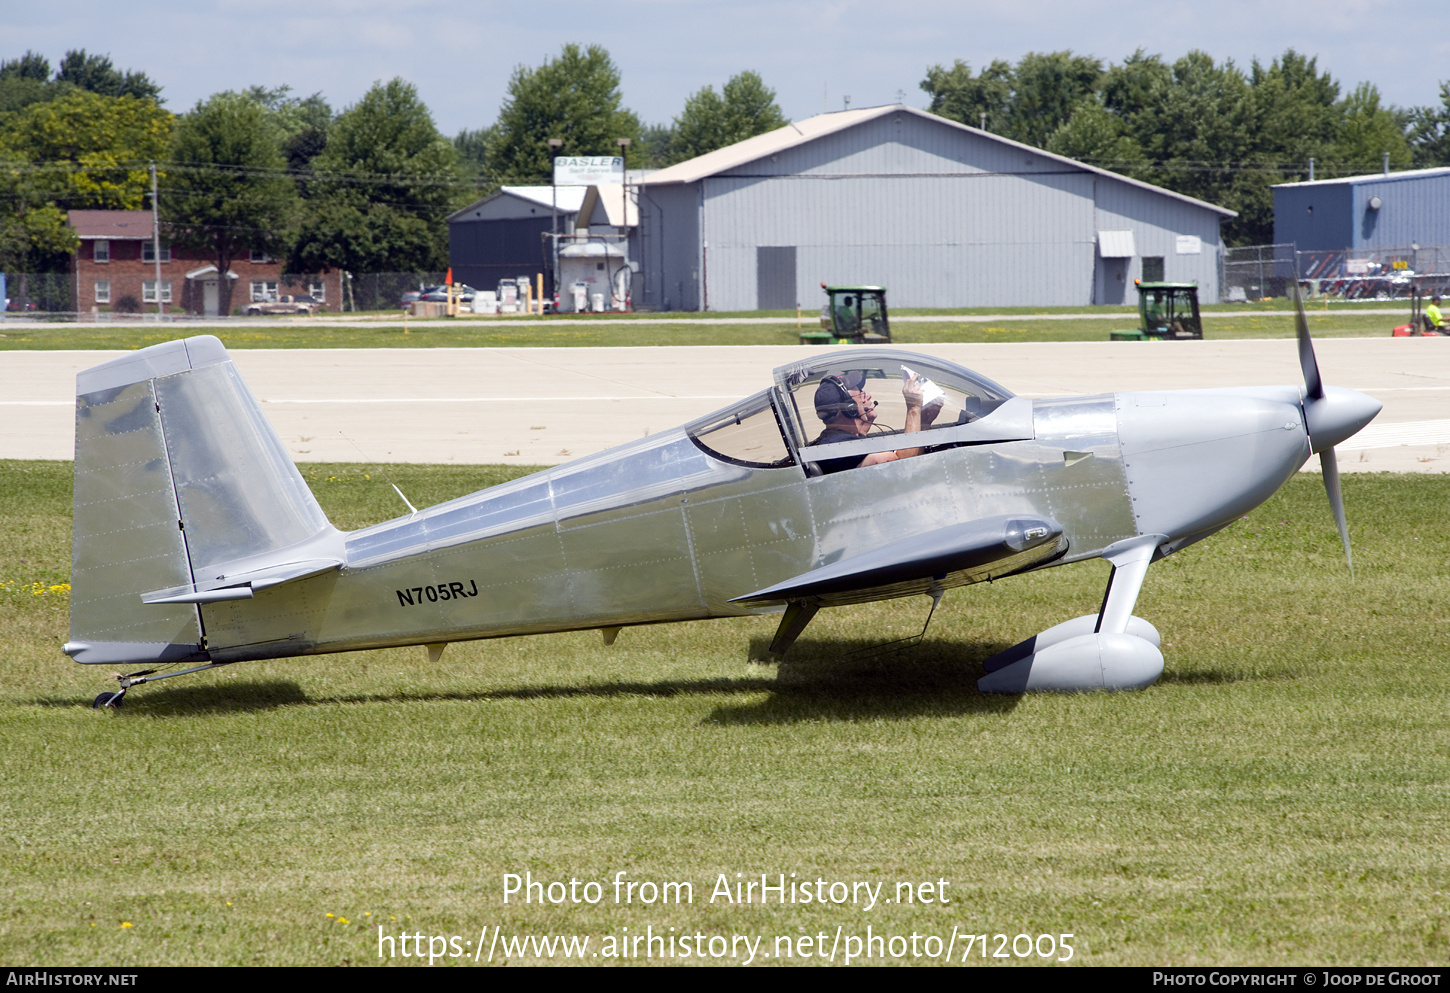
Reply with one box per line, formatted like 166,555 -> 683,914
731,515 -> 1067,606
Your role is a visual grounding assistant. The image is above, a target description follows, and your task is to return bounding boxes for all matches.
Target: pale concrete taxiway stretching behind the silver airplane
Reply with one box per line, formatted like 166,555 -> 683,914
0,339 -> 1450,473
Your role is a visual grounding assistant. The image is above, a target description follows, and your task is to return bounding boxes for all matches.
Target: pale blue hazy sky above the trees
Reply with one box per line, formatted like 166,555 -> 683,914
0,0 -> 1450,135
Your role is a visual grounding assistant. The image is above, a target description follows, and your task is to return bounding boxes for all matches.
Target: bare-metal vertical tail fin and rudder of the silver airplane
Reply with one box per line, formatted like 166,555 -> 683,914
65,335 -> 341,664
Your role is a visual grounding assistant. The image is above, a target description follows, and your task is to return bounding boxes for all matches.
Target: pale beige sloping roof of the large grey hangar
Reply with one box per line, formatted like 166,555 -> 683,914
643,103 -> 1238,217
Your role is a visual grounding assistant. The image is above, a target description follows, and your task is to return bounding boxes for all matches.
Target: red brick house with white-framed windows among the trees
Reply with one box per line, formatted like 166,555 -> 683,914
70,210 -> 342,317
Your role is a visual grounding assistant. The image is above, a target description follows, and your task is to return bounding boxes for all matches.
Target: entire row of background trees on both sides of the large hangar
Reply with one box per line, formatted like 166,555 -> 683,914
8,45 -> 1450,294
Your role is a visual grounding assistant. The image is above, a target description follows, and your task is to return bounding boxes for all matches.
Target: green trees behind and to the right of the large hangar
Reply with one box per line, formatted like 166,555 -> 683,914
921,49 -> 1432,245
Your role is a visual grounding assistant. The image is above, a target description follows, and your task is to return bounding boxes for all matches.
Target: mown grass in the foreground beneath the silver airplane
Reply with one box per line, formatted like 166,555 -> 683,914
0,462 -> 1450,965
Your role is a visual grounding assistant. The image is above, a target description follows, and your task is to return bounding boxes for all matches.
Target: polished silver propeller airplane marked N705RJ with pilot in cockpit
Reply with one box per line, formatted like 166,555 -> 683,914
64,298 -> 1380,707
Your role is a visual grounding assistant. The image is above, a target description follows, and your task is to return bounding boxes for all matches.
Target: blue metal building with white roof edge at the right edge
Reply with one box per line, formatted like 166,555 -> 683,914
1273,168 -> 1450,252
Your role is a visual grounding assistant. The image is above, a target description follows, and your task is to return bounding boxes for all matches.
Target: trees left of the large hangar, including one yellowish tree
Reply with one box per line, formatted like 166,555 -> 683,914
0,45 -> 786,301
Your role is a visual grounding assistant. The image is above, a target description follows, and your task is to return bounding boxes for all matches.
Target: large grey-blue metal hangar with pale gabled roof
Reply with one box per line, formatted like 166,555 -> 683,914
632,106 -> 1234,310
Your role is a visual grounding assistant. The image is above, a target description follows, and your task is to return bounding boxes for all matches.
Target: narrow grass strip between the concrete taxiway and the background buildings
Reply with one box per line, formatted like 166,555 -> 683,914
0,304 -> 1408,351
